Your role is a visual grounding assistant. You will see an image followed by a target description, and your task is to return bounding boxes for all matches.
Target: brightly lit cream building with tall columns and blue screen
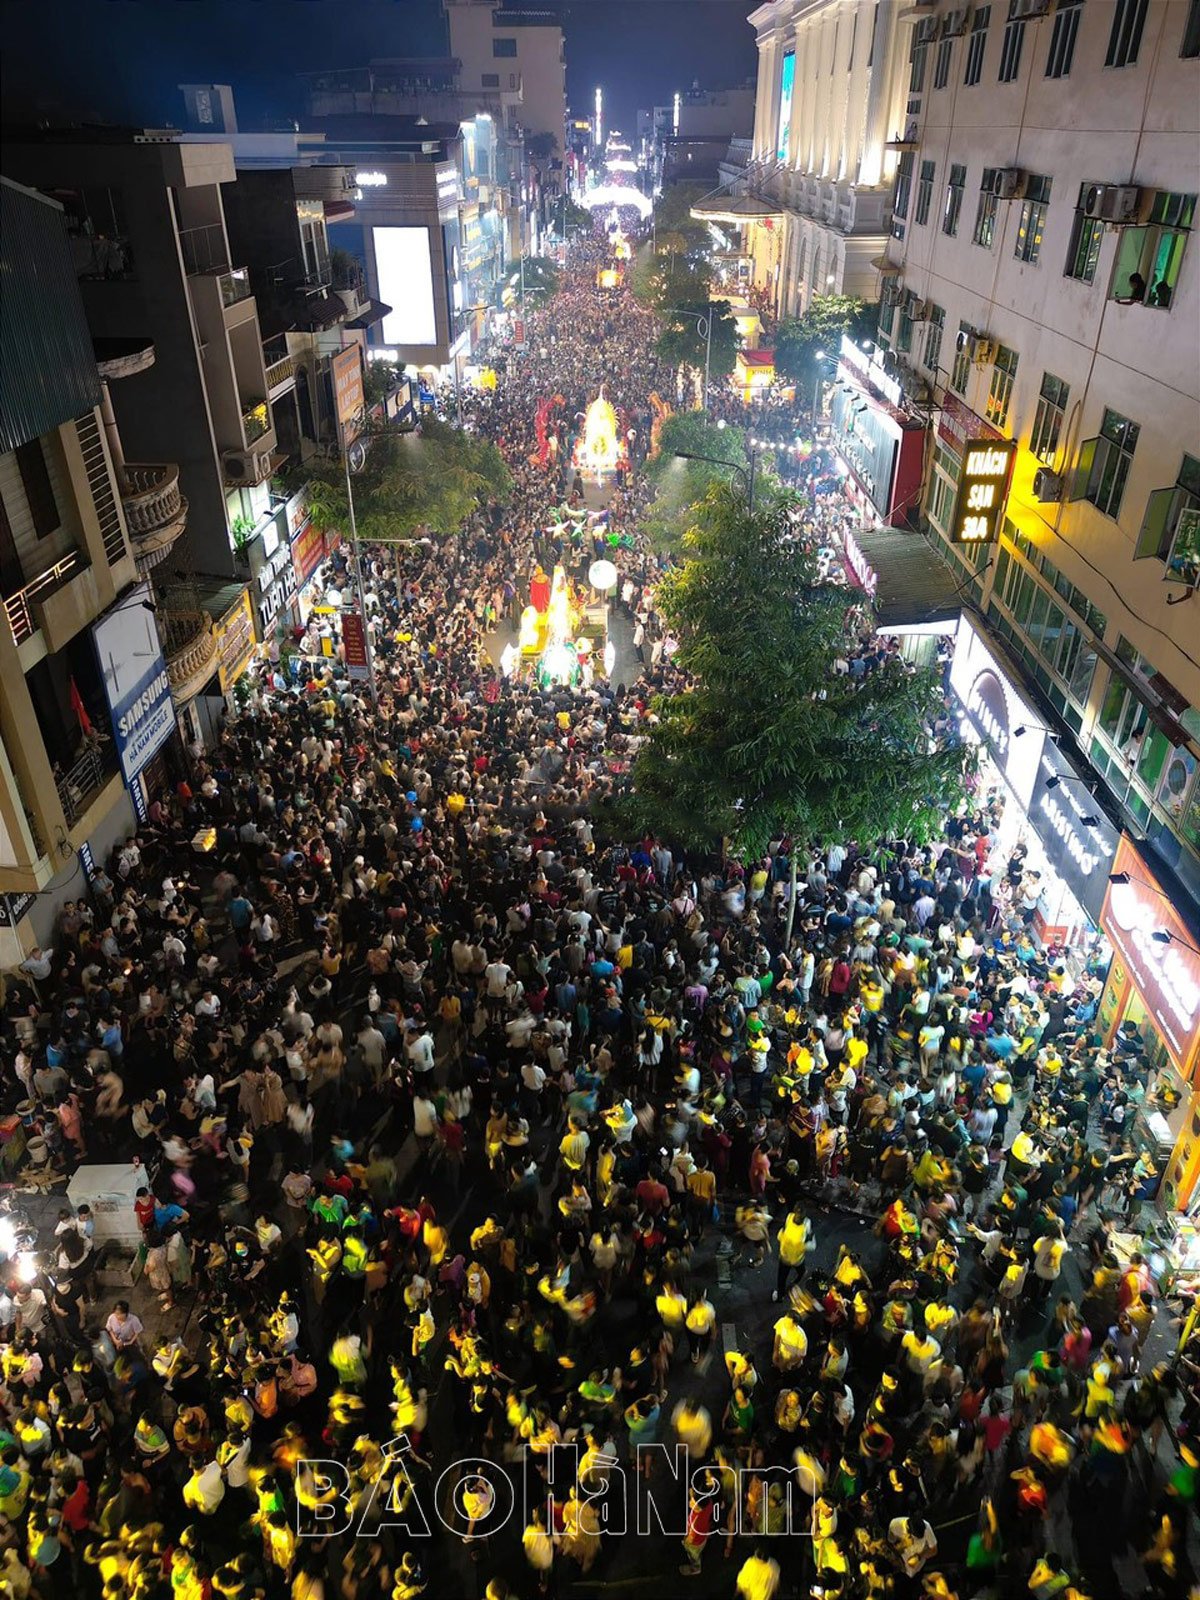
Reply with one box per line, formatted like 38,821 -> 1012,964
713,0 -> 914,317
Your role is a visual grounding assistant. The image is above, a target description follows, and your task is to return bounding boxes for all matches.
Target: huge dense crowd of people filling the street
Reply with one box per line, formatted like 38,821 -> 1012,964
0,216 -> 1200,1600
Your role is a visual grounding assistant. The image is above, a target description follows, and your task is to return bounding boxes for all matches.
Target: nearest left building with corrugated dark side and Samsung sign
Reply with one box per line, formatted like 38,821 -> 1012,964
0,178 -> 162,947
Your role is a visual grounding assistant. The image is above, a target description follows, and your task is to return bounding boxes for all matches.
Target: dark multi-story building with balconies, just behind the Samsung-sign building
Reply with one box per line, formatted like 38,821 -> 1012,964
5,128 -> 285,726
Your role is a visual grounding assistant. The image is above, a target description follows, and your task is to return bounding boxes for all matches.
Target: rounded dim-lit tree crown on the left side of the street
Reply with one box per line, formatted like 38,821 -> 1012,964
306,418 -> 510,544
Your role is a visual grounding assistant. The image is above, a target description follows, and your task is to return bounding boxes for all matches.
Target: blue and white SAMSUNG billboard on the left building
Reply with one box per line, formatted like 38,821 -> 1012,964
91,584 -> 174,789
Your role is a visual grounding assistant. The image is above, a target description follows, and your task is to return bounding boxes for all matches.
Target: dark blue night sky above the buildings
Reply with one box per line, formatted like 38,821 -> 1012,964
0,0 -> 755,133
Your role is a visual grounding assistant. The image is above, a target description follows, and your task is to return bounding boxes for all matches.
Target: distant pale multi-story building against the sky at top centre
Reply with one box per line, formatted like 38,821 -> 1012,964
445,0 -> 566,154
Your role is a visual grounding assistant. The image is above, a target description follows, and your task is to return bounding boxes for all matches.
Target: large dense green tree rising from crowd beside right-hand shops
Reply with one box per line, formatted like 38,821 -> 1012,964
626,485 -> 963,859
